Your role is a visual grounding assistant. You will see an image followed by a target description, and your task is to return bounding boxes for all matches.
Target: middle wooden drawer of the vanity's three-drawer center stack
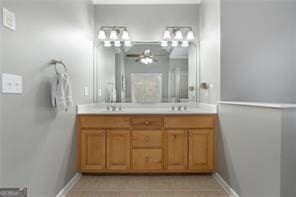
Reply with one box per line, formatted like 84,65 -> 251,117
133,130 -> 162,148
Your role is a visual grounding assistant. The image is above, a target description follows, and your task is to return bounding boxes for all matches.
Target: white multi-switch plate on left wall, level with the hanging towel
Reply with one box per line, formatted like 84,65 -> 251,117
2,73 -> 23,94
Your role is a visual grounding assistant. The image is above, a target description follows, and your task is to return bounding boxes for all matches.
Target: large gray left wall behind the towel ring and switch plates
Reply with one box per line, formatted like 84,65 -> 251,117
0,1 -> 93,197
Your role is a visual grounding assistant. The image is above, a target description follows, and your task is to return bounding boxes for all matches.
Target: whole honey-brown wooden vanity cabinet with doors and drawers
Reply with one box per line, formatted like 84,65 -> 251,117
78,115 -> 216,173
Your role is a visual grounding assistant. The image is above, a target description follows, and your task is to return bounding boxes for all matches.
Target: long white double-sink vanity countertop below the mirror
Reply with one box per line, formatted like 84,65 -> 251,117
77,103 -> 217,115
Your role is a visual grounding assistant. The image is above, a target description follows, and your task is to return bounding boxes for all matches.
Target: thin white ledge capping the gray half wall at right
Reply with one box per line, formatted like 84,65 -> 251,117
219,101 -> 296,109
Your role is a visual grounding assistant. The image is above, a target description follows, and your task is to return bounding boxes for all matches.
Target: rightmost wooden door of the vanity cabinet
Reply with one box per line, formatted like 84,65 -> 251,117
189,129 -> 214,172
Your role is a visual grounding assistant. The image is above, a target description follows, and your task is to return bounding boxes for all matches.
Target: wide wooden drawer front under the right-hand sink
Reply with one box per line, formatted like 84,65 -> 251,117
164,115 -> 215,129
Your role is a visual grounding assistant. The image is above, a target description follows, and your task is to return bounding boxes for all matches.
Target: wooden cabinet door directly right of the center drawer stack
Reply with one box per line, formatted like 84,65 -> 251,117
165,130 -> 188,171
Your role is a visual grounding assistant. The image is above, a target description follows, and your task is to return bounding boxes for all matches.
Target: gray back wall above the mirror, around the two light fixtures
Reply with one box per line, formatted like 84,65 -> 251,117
95,5 -> 198,41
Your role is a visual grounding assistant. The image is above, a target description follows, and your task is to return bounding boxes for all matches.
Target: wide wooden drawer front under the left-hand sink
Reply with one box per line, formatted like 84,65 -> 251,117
80,116 -> 130,129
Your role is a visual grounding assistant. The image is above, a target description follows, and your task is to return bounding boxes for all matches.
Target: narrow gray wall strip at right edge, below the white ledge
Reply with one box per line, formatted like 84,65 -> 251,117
281,109 -> 296,197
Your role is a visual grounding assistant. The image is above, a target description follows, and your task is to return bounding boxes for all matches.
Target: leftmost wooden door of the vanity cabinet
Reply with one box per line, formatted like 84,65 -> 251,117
80,130 -> 105,171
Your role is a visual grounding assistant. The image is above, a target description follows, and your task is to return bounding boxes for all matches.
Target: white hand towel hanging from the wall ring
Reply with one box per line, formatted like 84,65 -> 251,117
51,73 -> 73,111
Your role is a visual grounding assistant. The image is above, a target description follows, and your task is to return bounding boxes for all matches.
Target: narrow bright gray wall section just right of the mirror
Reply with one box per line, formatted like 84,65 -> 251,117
199,0 -> 221,104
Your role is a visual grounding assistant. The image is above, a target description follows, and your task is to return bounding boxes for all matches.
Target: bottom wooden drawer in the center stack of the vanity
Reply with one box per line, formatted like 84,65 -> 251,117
132,149 -> 162,171
